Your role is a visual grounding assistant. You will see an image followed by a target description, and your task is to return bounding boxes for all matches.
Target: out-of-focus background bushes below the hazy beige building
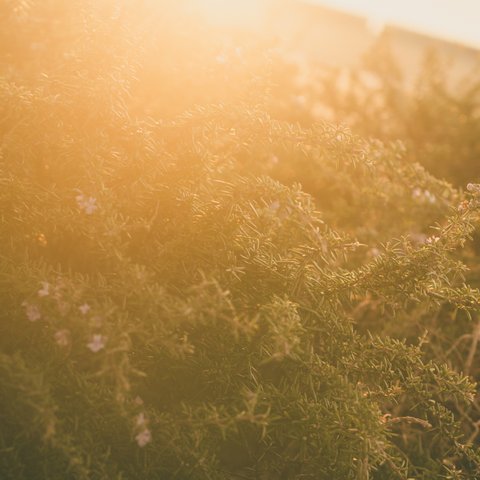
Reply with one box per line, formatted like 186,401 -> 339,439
271,36 -> 480,187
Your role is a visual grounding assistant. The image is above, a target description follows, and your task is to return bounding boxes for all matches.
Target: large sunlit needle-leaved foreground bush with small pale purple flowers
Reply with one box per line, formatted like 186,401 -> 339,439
0,0 -> 480,480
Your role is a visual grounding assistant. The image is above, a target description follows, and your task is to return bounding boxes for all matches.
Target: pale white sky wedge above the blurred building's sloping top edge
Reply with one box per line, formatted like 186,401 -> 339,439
309,0 -> 480,48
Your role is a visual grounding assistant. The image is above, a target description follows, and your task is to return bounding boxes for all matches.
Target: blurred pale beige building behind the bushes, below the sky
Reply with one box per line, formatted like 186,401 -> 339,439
264,0 -> 480,84
